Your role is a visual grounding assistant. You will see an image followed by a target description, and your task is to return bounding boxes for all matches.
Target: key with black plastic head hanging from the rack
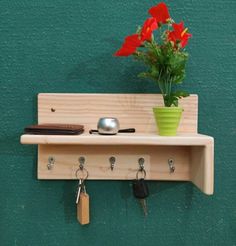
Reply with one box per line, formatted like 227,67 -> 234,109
133,178 -> 149,216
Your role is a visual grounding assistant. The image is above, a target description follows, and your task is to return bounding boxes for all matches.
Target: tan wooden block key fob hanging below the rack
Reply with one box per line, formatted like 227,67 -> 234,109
77,192 -> 89,225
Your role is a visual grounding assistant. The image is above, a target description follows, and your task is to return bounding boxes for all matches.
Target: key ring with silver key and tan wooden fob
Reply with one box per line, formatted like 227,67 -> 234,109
76,168 -> 89,225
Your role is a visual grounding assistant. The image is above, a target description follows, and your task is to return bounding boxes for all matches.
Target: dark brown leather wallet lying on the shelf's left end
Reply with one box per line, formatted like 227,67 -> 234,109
24,124 -> 84,135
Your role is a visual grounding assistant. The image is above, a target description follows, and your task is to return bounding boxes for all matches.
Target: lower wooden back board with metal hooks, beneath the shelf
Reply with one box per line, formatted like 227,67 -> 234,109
38,145 -> 190,181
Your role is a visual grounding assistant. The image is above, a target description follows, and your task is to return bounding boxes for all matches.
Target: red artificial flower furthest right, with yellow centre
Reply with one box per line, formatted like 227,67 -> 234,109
167,21 -> 192,48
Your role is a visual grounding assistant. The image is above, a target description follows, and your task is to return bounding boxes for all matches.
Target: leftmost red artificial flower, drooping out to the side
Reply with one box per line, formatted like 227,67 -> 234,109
114,34 -> 142,56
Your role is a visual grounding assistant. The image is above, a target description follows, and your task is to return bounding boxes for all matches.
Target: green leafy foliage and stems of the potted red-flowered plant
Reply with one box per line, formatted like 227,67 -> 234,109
134,39 -> 189,107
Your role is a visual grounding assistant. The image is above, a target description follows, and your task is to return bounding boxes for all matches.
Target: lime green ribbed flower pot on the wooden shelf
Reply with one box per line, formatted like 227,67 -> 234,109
153,107 -> 183,136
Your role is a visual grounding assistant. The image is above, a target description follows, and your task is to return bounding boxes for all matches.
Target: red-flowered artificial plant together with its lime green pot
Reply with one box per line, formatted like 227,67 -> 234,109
114,2 -> 192,136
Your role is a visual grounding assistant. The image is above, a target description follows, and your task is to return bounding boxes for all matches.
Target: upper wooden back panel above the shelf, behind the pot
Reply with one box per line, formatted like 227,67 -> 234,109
38,93 -> 198,133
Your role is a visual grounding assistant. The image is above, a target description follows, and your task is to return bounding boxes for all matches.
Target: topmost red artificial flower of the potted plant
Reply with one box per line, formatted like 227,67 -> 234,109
148,2 -> 170,24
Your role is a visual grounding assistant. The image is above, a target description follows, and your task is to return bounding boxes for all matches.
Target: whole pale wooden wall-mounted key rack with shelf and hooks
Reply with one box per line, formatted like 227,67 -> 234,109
21,94 -> 214,195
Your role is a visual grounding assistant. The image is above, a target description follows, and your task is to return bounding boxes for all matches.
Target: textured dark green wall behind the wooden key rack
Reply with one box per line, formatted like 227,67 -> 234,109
0,0 -> 236,246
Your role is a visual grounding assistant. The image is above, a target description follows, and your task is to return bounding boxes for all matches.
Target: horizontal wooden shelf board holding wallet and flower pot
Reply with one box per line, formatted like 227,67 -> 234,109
21,133 -> 214,146
